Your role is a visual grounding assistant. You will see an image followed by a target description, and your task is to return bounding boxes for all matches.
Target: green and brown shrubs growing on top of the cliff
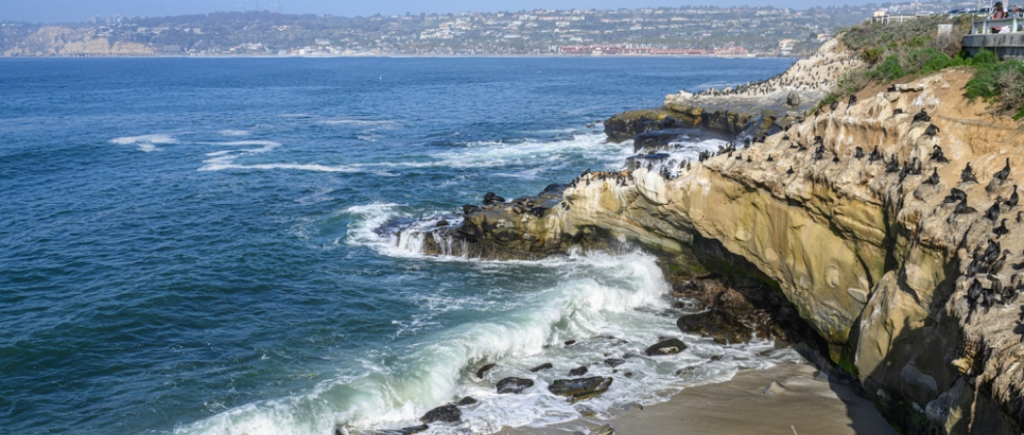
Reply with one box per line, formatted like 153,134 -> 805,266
812,15 -> 1024,119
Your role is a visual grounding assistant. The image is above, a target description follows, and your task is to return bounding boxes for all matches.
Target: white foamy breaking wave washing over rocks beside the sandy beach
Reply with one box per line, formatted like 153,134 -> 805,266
175,248 -> 797,435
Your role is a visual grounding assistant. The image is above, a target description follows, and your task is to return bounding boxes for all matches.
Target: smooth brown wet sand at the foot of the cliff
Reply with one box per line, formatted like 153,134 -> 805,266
501,363 -> 897,435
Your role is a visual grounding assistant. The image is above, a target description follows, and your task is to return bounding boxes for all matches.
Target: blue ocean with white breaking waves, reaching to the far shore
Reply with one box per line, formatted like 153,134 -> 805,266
0,58 -> 795,435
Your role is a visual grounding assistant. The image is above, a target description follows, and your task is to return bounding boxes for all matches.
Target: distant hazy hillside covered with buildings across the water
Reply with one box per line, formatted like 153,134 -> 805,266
0,3 -> 970,56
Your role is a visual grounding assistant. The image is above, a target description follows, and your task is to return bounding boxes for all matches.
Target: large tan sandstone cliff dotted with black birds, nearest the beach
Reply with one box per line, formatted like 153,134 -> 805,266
417,60 -> 1024,434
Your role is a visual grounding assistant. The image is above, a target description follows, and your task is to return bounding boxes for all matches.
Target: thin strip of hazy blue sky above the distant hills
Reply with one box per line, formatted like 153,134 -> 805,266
0,0 -> 885,23
